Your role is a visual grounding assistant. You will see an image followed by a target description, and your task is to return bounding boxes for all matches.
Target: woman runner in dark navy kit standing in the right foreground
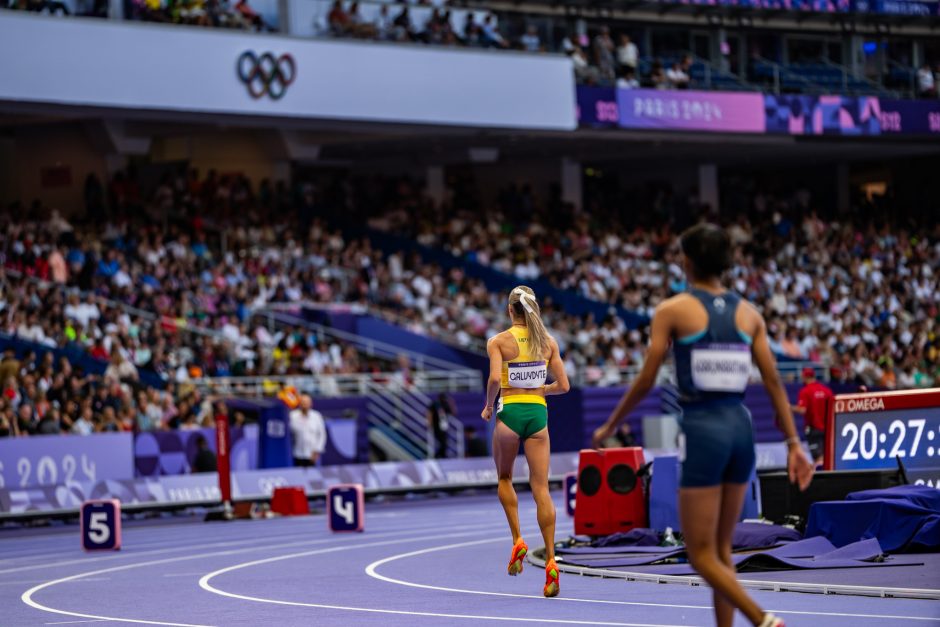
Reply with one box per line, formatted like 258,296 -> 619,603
594,224 -> 813,627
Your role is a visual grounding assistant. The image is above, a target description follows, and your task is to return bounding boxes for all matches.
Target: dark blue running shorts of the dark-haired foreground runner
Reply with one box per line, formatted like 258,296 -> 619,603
679,402 -> 756,488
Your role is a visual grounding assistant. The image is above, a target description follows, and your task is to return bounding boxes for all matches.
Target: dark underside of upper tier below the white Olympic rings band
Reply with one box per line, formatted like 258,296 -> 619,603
0,104 -> 940,167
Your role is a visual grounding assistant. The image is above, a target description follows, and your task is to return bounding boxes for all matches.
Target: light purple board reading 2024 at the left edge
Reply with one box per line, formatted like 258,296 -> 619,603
0,433 -> 134,489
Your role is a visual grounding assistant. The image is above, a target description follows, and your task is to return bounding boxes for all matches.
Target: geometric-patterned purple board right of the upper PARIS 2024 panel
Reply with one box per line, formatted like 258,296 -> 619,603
764,95 -> 881,136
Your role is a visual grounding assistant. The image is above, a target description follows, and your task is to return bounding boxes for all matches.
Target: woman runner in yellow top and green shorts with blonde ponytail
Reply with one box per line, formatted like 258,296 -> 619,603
480,286 -> 569,597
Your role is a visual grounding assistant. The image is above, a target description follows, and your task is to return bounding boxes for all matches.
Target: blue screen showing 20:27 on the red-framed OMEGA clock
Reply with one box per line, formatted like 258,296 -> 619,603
835,407 -> 940,470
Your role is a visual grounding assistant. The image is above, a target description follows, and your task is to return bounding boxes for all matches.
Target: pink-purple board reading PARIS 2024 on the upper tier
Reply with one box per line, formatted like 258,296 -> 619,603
617,89 -> 764,133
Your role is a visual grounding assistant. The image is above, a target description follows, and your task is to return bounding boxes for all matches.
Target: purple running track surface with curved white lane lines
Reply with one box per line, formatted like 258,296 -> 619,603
0,493 -> 940,627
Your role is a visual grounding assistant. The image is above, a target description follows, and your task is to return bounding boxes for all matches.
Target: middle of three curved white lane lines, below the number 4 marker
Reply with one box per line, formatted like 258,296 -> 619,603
199,529 -> 692,627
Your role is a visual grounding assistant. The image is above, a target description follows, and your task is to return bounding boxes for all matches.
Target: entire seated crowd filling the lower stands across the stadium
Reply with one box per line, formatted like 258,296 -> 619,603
0,172 -> 940,440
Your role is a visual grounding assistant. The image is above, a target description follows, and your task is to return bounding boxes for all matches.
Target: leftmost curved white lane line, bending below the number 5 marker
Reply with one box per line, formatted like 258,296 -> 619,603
20,524 -> 488,627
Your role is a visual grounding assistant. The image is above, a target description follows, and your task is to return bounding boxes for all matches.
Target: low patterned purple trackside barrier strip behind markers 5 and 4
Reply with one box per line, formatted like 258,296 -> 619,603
0,453 -> 578,519
